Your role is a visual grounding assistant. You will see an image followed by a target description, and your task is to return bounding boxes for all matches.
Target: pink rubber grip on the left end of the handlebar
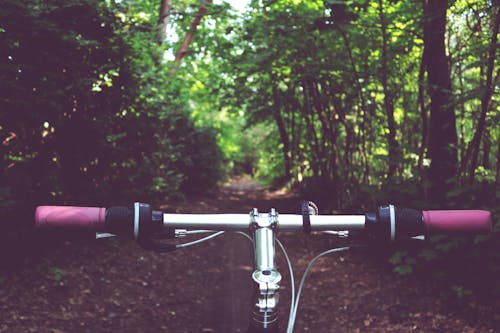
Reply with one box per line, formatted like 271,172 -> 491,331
35,206 -> 106,231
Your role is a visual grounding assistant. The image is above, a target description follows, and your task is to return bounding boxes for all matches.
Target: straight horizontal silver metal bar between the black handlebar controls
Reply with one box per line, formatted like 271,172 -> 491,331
163,214 -> 365,231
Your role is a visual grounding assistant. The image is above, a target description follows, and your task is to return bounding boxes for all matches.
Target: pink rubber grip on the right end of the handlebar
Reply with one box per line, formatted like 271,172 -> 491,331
422,210 -> 492,234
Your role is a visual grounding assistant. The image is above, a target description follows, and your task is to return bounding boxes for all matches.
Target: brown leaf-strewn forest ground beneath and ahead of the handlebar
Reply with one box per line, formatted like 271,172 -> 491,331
0,178 -> 500,333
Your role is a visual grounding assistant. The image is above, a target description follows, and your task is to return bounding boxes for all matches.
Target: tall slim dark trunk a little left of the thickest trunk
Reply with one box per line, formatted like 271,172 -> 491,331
378,0 -> 399,178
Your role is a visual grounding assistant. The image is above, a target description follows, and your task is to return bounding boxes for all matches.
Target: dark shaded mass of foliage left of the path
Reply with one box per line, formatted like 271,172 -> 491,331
0,0 -> 221,233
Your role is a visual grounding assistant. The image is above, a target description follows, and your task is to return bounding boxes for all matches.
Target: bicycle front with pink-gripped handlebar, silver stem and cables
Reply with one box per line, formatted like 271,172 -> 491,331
35,201 -> 492,333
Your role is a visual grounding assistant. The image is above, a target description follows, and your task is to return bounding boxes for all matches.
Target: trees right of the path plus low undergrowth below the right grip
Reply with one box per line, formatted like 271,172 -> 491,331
197,0 -> 500,295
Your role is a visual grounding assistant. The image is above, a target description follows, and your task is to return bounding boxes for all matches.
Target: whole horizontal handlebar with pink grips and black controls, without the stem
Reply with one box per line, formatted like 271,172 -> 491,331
35,203 -> 492,244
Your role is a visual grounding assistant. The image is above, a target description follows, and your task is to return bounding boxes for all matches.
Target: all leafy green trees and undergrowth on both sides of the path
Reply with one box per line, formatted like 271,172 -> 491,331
0,0 -> 500,298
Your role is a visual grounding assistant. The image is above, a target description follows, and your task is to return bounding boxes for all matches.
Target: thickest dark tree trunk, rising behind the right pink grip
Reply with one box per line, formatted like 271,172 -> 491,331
423,0 -> 457,203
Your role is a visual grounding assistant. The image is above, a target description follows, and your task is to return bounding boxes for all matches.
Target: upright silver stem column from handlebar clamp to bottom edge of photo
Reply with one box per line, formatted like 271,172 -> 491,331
248,208 -> 281,333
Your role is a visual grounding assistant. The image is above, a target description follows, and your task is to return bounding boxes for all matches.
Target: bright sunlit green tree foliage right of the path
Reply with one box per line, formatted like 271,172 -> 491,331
190,0 -> 498,209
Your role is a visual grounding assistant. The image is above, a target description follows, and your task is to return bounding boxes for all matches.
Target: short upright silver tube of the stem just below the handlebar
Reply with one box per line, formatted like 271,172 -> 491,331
254,228 -> 276,271
